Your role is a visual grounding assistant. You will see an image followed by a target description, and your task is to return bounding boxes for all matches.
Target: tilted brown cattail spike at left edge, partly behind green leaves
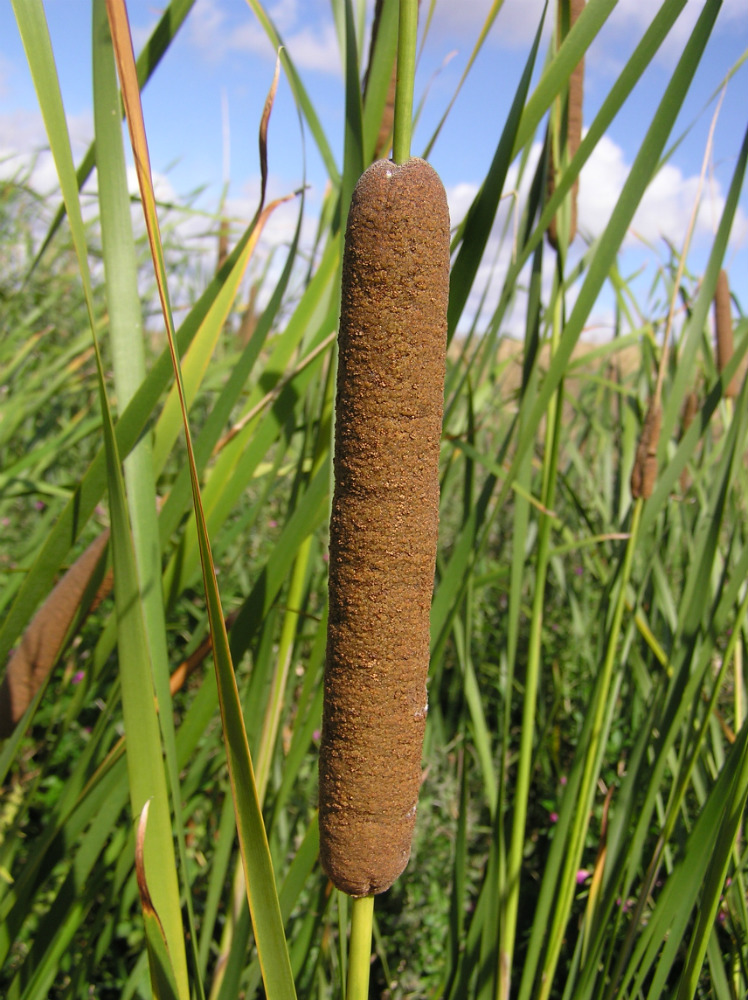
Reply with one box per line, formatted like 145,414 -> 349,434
0,529 -> 112,739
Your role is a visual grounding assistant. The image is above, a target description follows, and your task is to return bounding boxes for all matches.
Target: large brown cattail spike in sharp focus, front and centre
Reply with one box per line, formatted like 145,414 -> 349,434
319,159 -> 449,896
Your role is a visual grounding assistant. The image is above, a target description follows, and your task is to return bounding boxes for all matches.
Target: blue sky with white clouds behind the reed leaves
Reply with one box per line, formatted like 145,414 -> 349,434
0,0 -> 748,338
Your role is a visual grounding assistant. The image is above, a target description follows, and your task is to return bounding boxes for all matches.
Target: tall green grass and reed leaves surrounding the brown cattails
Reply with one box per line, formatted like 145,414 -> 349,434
0,0 -> 748,1000
